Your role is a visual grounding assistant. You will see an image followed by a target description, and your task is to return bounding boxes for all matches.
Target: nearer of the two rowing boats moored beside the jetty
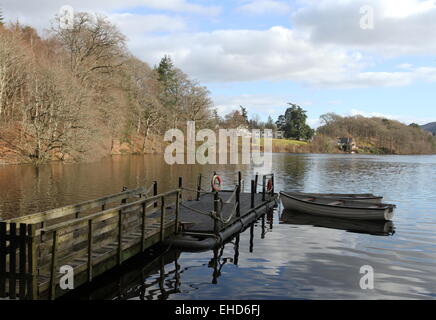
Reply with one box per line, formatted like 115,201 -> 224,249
280,193 -> 394,221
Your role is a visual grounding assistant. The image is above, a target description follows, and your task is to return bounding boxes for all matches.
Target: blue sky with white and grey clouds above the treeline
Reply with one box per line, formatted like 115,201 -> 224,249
0,0 -> 436,126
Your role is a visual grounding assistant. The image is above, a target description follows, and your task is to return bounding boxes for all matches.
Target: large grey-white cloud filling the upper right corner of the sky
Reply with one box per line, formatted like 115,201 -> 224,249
292,0 -> 436,56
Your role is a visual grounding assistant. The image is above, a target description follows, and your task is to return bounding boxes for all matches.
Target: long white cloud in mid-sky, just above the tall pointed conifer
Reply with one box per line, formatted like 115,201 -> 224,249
135,27 -> 361,83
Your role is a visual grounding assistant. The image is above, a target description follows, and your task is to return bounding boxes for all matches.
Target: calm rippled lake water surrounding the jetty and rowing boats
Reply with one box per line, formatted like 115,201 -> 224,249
0,154 -> 436,299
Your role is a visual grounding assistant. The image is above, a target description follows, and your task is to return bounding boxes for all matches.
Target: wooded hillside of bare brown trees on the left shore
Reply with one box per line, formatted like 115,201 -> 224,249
0,12 -> 216,163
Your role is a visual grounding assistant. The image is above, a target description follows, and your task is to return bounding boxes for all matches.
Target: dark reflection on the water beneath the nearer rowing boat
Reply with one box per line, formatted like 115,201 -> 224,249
280,210 -> 395,236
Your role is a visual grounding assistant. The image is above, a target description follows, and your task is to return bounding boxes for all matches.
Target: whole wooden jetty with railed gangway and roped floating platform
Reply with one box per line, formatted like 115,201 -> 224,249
0,173 -> 277,300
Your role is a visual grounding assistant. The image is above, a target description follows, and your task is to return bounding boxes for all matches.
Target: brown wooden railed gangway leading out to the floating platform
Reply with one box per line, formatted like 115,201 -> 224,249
0,186 -> 181,299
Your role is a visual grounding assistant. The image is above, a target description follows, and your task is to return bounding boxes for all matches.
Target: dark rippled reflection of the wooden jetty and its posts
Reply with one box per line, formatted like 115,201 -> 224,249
61,210 -> 273,300
